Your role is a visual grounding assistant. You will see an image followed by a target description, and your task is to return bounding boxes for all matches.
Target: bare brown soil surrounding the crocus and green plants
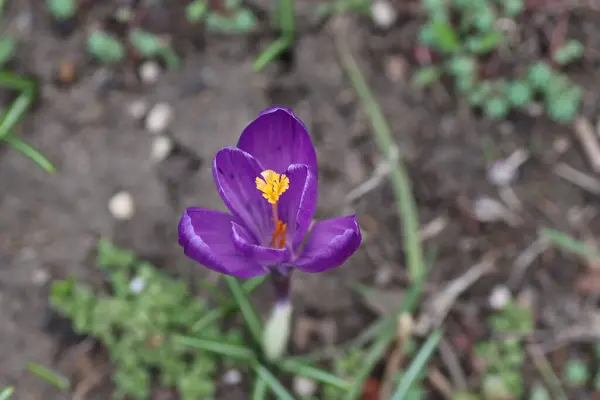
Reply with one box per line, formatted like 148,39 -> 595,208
0,0 -> 600,400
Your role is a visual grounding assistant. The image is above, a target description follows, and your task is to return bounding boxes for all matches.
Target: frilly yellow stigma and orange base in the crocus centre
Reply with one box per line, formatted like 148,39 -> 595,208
256,169 -> 290,249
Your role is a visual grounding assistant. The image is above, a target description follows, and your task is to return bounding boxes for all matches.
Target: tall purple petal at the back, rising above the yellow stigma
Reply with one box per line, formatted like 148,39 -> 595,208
237,107 -> 317,175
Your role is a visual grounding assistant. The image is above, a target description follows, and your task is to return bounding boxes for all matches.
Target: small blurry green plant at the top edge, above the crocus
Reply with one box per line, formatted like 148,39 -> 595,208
185,0 -> 257,34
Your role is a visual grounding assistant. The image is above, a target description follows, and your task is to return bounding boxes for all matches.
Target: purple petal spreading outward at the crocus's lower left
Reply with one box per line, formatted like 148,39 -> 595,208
179,208 -> 268,278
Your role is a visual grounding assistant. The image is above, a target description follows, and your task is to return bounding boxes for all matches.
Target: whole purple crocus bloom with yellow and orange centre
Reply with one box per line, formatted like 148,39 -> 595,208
179,107 -> 361,297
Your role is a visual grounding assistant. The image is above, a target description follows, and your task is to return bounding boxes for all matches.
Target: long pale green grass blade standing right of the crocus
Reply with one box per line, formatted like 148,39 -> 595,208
336,30 -> 427,281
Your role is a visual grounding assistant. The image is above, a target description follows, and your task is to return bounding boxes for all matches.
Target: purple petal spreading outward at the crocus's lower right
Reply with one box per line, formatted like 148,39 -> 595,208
292,216 -> 361,273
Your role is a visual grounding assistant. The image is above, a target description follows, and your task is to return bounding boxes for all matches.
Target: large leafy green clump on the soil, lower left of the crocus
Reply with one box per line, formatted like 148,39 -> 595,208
50,241 -> 241,400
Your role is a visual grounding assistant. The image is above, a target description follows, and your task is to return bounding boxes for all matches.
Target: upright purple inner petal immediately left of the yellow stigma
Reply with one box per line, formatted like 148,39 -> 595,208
213,147 -> 273,245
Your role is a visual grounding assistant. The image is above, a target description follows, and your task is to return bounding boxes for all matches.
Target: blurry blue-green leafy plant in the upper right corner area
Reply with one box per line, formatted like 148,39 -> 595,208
413,0 -> 583,123
